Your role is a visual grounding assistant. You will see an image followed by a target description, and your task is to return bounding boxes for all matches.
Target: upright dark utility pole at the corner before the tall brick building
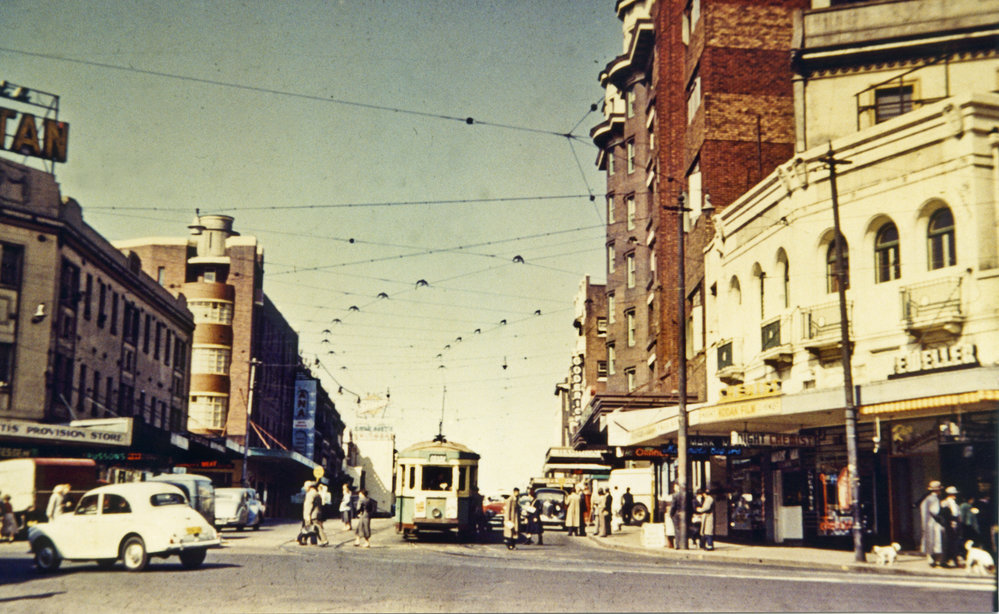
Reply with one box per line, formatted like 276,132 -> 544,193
663,192 -> 690,550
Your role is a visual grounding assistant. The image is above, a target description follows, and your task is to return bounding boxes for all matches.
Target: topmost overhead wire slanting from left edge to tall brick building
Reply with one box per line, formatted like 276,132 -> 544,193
0,47 -> 600,141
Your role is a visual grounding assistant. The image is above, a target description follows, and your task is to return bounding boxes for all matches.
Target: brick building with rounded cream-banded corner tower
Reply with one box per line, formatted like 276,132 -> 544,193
116,215 -> 315,514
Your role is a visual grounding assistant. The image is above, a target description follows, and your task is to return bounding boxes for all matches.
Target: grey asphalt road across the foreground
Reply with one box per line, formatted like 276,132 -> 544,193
0,520 -> 996,614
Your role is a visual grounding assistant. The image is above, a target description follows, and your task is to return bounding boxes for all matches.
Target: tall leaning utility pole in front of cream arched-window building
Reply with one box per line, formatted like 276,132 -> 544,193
819,143 -> 866,563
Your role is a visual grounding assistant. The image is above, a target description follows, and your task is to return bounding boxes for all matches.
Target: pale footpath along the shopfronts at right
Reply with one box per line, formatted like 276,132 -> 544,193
586,524 -> 996,584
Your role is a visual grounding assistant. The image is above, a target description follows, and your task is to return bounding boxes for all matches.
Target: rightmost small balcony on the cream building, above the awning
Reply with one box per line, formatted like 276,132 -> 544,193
902,277 -> 965,342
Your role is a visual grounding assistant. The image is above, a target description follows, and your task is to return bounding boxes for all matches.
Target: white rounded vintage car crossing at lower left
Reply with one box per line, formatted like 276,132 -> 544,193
28,482 -> 221,571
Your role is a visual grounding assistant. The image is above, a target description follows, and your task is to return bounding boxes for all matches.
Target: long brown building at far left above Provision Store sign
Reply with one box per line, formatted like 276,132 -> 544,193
0,154 -> 196,469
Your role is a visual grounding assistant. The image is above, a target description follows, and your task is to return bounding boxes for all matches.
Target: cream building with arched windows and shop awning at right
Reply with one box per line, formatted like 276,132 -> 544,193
610,0 -> 999,547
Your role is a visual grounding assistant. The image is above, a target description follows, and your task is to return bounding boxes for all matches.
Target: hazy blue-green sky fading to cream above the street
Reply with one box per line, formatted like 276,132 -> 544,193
0,0 -> 622,489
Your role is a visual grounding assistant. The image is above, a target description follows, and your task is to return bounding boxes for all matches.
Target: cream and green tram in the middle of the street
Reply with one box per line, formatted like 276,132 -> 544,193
395,437 -> 482,539
